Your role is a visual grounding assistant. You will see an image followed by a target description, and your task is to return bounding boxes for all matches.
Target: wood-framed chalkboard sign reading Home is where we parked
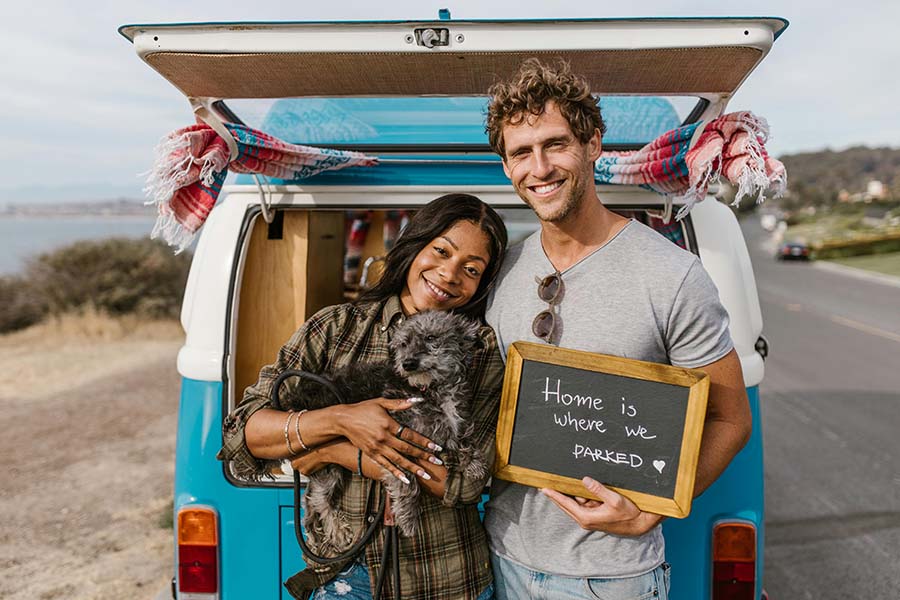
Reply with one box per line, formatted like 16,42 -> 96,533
494,342 -> 709,517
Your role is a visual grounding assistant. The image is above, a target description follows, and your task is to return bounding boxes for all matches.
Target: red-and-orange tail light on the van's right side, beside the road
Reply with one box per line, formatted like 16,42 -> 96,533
712,523 -> 756,600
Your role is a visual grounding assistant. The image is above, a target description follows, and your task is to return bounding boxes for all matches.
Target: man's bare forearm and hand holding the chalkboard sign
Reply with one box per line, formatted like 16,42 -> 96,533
542,350 -> 753,536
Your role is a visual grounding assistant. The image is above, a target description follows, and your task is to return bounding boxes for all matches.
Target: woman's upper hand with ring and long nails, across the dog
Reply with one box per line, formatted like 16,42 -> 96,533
329,398 -> 443,483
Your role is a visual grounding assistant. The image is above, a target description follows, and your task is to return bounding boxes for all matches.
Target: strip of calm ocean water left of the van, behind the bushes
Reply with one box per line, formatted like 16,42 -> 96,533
0,215 -> 156,275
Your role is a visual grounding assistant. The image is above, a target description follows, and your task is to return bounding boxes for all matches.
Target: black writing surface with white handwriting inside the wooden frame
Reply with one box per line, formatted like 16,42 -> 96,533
509,361 -> 688,496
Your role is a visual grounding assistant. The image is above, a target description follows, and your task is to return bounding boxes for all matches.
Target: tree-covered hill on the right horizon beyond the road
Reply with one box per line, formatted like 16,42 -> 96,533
779,146 -> 900,204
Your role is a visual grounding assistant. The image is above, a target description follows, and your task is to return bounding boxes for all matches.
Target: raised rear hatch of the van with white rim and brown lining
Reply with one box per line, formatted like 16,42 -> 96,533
119,17 -> 787,134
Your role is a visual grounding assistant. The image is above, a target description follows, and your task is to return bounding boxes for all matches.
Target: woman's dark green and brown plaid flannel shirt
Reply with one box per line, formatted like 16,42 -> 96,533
218,297 -> 503,600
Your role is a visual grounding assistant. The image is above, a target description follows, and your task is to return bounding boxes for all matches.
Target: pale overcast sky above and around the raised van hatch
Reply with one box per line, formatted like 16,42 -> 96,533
0,0 -> 900,201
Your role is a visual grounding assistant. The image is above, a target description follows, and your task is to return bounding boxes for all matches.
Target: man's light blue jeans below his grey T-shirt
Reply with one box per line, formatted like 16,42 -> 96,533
491,554 -> 669,600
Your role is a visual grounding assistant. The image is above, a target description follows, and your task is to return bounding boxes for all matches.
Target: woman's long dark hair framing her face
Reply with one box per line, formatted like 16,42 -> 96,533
359,194 -> 506,320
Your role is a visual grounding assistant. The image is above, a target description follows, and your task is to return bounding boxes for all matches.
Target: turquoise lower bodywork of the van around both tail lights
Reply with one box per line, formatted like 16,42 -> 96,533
175,379 -> 765,600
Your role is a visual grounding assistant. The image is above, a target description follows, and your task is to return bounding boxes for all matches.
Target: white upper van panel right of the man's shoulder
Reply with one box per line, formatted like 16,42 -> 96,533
691,198 -> 764,387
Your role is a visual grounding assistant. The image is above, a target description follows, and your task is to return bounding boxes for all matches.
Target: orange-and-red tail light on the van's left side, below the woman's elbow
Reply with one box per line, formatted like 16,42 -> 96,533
178,506 -> 219,594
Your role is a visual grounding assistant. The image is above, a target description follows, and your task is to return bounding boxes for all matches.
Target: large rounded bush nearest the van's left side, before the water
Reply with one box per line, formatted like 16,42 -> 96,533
25,238 -> 191,318
